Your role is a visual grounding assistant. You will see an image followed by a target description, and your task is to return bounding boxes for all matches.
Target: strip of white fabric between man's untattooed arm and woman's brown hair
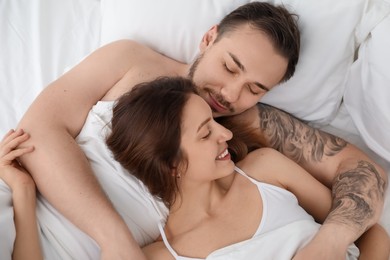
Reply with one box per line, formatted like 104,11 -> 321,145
76,101 -> 168,245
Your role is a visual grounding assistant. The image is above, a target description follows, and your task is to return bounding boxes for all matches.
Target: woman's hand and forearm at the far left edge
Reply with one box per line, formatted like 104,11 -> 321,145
0,129 -> 43,260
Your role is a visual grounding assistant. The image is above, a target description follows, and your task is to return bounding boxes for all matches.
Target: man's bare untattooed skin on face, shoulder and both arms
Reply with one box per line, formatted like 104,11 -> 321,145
19,23 -> 387,259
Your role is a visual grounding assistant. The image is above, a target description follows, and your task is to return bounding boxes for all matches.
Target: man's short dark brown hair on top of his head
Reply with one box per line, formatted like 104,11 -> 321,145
215,2 -> 300,81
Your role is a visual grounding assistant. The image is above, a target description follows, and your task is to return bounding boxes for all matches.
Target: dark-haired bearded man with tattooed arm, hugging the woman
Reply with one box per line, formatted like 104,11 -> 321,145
19,2 -> 387,259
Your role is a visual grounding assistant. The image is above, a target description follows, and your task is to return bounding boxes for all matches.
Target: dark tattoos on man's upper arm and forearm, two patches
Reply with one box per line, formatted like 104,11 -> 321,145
257,103 -> 387,234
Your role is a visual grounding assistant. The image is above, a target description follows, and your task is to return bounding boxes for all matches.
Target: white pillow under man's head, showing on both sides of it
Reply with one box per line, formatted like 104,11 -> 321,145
101,0 -> 367,124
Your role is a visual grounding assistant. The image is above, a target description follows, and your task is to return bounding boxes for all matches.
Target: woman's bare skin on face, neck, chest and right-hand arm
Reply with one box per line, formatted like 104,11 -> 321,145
143,95 -> 389,259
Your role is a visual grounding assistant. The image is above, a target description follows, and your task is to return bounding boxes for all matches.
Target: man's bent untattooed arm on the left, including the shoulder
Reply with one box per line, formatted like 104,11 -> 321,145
19,41 -> 148,259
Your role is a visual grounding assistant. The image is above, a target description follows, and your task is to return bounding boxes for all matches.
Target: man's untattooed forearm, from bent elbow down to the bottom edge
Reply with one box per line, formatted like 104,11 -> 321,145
16,122 -> 143,259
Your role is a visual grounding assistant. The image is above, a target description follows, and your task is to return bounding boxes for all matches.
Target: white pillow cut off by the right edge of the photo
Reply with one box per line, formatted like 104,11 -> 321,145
344,12 -> 390,162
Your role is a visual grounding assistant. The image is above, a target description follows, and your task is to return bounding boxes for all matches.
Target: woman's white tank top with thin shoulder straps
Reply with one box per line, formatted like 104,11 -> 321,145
158,167 -> 314,260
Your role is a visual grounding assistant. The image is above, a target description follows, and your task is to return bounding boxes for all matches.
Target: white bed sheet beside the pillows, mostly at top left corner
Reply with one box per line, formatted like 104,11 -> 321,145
0,0 -> 390,256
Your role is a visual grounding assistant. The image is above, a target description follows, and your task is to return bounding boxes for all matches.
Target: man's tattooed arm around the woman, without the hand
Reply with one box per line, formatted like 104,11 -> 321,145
257,103 -> 387,248
